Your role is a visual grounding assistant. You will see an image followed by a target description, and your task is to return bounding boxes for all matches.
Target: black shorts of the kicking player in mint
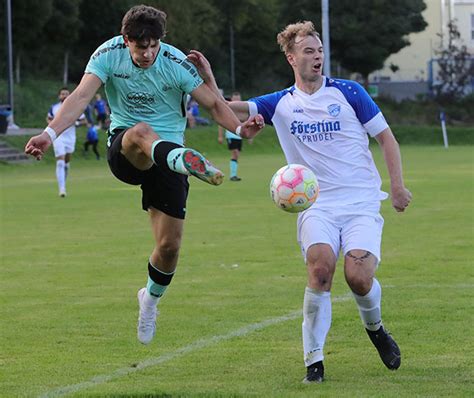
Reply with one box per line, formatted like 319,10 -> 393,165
107,129 -> 189,219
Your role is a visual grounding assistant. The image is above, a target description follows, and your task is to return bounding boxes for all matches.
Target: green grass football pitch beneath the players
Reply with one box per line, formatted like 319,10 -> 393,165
0,131 -> 474,397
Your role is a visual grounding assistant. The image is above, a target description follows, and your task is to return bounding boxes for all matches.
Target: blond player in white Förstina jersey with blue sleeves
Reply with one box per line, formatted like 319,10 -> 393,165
190,21 -> 411,383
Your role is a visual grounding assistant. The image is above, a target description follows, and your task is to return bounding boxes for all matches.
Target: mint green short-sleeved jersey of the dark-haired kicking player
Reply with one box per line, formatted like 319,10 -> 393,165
85,36 -> 203,145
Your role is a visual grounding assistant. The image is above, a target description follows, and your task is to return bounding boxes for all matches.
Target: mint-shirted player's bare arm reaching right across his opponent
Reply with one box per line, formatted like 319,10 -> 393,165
191,84 -> 265,138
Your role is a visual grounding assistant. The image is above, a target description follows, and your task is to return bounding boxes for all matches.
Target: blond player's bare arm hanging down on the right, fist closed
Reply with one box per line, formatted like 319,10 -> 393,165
375,128 -> 412,212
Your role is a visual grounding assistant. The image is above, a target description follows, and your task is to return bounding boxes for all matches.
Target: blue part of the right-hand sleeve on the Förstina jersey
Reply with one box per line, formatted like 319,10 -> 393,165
333,80 -> 380,124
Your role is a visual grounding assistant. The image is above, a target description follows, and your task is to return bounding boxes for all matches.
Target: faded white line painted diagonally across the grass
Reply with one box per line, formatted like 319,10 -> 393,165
40,294 -> 352,398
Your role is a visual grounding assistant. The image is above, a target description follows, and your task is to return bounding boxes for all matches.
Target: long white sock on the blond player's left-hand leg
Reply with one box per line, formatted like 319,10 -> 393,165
302,287 -> 331,366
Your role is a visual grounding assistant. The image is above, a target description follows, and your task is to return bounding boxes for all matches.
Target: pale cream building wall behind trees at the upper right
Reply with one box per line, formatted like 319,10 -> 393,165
369,0 -> 474,82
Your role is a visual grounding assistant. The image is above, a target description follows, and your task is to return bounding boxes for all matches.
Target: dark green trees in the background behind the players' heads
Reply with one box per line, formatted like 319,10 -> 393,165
0,0 -> 427,93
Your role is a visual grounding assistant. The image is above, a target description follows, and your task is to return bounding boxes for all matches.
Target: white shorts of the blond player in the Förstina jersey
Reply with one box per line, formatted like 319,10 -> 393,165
297,202 -> 384,263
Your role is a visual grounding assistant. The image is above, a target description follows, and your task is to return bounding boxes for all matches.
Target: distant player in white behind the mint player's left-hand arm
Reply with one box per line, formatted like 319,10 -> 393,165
46,87 -> 85,198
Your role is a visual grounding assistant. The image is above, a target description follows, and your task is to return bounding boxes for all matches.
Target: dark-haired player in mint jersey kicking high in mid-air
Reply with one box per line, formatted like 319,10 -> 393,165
25,5 -> 264,344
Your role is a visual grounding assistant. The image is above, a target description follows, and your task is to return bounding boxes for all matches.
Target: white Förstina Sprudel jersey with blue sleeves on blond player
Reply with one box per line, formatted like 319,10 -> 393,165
248,77 -> 388,207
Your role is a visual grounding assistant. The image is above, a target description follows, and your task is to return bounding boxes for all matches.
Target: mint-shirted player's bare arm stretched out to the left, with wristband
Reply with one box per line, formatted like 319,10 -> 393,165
25,74 -> 102,160
